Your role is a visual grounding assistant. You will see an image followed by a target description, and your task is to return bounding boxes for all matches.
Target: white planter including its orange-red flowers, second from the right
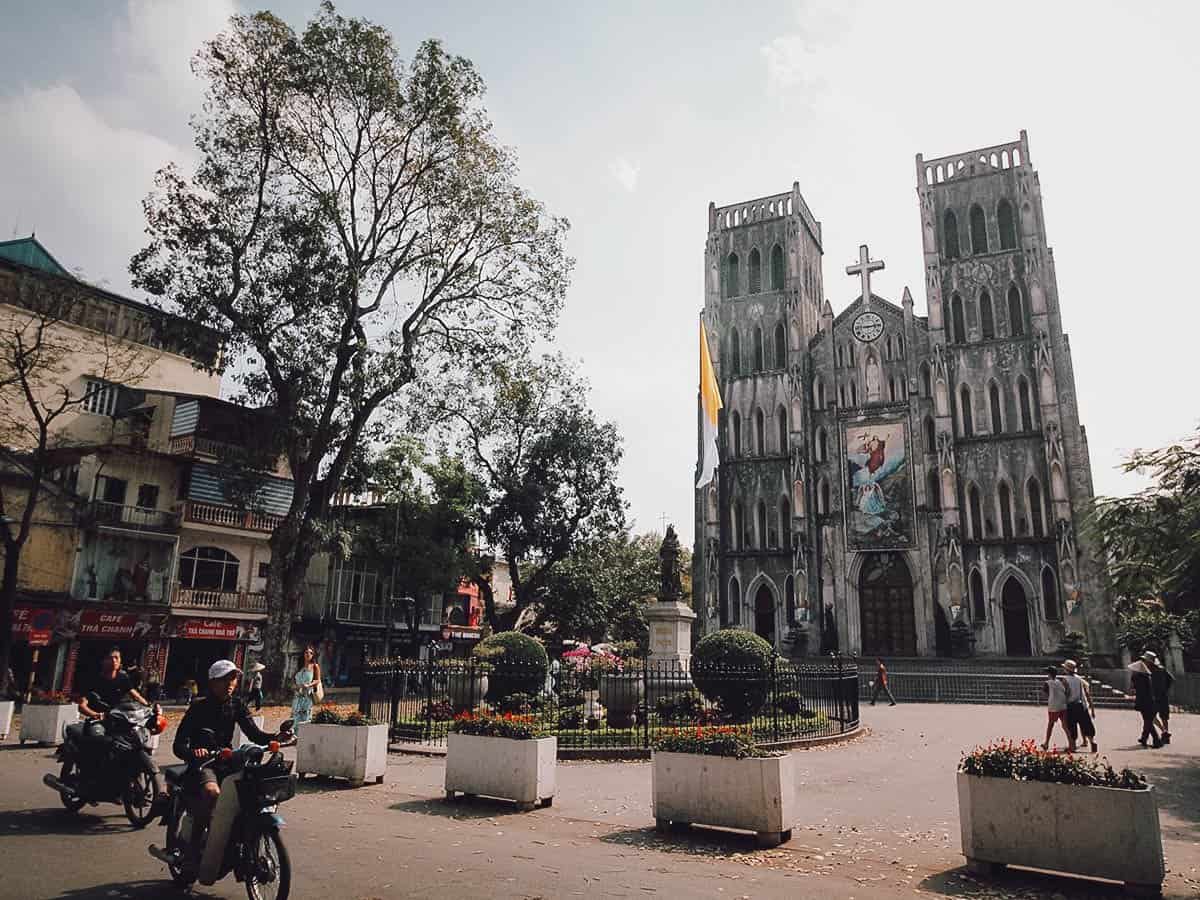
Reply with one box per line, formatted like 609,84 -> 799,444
650,725 -> 797,847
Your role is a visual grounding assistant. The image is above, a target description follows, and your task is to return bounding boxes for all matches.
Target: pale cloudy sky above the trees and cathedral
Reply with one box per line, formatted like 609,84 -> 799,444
0,0 -> 1200,541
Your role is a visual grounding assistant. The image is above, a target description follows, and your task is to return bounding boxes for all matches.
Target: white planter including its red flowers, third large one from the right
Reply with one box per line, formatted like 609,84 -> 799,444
445,713 -> 558,811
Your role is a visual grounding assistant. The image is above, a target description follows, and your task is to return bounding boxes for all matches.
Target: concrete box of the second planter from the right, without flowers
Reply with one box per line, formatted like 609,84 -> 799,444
650,750 -> 799,847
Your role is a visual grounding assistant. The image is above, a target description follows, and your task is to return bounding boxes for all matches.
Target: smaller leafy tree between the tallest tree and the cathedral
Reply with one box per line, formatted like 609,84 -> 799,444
430,356 -> 625,630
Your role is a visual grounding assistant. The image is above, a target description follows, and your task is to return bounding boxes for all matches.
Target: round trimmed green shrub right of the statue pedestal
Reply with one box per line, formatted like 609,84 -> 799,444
691,628 -> 775,721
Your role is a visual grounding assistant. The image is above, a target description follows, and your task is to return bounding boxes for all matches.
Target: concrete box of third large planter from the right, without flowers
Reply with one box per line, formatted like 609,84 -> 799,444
445,732 -> 558,810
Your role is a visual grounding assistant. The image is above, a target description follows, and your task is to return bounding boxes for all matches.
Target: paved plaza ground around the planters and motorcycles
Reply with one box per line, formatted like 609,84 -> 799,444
0,704 -> 1200,900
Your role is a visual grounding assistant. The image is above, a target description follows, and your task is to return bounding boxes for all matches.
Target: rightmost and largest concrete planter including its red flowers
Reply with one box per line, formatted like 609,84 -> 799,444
958,740 -> 1165,895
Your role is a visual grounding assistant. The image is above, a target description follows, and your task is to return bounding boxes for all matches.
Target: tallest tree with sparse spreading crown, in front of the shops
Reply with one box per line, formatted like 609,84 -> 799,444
131,2 -> 570,690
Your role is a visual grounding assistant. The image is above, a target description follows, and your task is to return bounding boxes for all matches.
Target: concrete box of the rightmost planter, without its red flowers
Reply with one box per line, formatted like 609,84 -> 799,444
958,772 -> 1165,894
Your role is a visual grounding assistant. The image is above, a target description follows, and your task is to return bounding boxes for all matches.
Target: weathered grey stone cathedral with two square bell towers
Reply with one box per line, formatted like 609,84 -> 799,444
692,131 -> 1114,656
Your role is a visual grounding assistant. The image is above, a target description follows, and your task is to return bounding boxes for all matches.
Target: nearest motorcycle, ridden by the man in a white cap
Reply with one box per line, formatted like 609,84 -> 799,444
150,719 -> 296,900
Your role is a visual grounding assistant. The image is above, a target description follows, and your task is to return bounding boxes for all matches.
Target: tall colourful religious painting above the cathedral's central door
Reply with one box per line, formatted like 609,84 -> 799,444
842,419 -> 917,551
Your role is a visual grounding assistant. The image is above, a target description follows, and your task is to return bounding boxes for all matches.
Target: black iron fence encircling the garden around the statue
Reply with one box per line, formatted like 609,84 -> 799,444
359,659 -> 859,750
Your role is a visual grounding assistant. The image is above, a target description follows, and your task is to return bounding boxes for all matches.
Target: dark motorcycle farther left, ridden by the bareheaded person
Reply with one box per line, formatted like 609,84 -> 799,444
42,704 -> 167,828
